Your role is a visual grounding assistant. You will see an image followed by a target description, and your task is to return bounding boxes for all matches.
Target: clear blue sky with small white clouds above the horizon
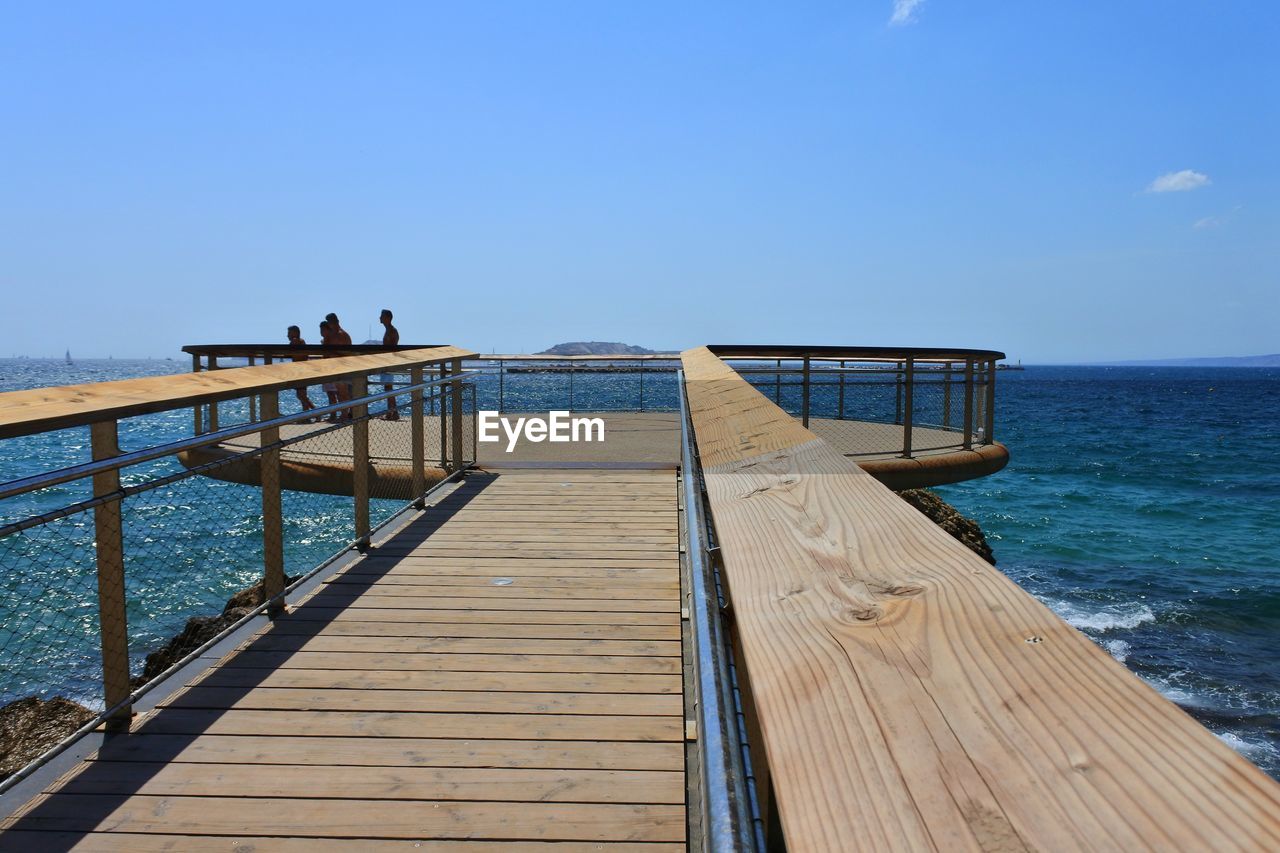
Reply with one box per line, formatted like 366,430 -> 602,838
0,0 -> 1280,362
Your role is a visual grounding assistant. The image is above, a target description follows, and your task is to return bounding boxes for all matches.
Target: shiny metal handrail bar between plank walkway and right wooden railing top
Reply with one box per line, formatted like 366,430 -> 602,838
678,371 -> 755,853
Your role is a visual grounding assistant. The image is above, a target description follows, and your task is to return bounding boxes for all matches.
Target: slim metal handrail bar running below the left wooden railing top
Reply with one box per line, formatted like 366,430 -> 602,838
0,371 -> 471,500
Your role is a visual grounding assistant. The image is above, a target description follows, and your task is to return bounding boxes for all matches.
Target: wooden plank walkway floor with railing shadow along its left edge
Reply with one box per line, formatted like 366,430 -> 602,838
0,470 -> 686,852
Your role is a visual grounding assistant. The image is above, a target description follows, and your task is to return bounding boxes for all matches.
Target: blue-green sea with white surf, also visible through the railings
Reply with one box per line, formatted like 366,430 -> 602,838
0,360 -> 1280,777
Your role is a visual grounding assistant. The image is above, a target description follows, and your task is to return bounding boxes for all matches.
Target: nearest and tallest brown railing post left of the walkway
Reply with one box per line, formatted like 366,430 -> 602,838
90,420 -> 132,731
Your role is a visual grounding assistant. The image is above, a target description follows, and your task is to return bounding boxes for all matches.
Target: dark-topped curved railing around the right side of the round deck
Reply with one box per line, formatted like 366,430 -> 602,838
710,346 -> 1005,459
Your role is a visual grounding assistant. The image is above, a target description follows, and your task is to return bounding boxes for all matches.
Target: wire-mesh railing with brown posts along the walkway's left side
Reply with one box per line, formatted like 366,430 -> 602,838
0,350 -> 476,786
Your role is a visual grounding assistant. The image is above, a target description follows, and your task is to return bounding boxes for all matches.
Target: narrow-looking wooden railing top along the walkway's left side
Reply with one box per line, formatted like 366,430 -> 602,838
0,346 -> 476,438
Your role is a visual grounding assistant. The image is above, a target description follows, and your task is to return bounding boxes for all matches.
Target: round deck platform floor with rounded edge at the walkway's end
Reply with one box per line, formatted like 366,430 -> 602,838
182,412 -> 1009,491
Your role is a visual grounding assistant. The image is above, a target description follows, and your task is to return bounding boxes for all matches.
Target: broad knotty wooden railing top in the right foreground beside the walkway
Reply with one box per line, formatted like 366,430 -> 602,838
682,347 -> 1280,853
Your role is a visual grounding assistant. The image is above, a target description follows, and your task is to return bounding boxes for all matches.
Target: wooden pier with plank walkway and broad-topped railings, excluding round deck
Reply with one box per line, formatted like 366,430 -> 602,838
0,347 -> 1280,853
